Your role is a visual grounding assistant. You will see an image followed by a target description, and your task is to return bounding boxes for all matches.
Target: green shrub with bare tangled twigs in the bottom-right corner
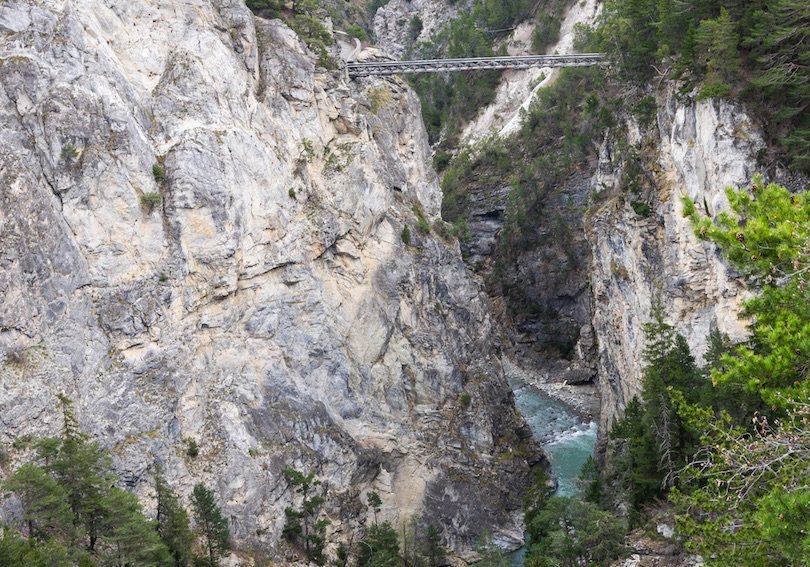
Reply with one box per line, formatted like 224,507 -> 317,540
671,412 -> 810,567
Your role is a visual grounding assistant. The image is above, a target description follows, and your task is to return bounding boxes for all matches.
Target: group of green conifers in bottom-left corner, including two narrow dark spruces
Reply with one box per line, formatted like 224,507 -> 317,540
0,396 -> 229,567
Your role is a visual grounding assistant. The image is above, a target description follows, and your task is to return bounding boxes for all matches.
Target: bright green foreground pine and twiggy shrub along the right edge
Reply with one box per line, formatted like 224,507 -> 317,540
671,179 -> 810,567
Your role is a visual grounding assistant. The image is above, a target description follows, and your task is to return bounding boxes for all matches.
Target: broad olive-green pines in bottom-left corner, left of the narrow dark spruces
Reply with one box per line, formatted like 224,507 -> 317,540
0,395 -> 178,567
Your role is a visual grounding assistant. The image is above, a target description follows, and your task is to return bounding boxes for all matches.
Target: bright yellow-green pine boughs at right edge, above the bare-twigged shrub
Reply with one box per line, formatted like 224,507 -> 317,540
684,178 -> 810,409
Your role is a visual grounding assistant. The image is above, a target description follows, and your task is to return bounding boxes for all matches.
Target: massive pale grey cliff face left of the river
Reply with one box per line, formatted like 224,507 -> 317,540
0,0 -> 532,560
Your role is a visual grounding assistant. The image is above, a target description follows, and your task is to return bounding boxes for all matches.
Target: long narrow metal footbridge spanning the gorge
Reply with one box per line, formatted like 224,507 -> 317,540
346,53 -> 607,77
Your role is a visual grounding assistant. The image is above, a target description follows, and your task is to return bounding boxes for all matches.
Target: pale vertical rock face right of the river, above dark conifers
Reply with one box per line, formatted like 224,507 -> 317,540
588,93 -> 764,429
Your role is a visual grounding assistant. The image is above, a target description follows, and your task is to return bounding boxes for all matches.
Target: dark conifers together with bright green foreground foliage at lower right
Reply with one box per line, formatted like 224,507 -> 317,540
572,183 -> 810,567
